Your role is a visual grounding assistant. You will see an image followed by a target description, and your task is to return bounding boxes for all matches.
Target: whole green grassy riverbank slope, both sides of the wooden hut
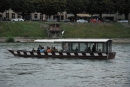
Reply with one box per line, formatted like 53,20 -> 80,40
0,21 -> 130,38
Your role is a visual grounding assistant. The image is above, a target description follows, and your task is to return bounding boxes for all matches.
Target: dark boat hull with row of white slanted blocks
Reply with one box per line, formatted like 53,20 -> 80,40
8,50 -> 116,59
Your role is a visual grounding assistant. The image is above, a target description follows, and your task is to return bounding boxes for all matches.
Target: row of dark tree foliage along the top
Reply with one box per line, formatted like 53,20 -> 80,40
0,0 -> 130,19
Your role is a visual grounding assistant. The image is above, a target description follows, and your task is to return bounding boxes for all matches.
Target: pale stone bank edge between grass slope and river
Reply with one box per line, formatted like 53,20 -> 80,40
0,37 -> 130,43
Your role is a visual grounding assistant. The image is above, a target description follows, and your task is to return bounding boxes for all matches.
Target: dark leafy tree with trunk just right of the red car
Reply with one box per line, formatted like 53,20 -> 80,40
84,0 -> 114,19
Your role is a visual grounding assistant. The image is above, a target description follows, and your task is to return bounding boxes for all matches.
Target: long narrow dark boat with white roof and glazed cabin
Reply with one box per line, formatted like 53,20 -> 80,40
8,39 -> 116,59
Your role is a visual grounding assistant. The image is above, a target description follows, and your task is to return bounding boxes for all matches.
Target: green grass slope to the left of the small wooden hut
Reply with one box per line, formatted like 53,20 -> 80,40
0,22 -> 45,37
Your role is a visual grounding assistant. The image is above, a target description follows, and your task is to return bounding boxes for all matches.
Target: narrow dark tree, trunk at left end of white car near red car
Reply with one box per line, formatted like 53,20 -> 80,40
66,0 -> 84,20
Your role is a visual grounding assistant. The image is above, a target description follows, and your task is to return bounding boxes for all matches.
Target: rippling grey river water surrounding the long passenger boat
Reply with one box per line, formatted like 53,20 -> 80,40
0,43 -> 130,87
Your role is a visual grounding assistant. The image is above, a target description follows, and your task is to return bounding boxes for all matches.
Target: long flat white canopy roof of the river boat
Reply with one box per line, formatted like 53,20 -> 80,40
34,39 -> 111,43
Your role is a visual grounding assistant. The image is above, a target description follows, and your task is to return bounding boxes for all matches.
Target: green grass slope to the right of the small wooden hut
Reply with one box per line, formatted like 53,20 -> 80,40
61,23 -> 130,38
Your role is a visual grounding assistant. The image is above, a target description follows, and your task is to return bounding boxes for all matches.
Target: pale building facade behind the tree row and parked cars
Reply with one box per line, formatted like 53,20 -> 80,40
0,9 -> 129,21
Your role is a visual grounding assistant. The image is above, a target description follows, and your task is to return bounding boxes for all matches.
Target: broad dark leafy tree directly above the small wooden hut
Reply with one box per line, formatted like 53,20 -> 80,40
37,0 -> 65,17
